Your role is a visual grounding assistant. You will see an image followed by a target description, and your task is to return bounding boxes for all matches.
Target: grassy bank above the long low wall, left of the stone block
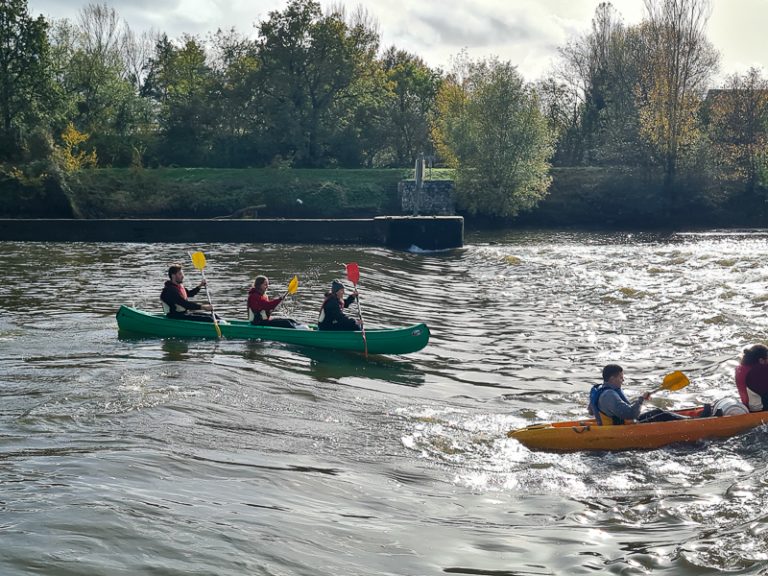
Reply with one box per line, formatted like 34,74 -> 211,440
0,168 -> 412,218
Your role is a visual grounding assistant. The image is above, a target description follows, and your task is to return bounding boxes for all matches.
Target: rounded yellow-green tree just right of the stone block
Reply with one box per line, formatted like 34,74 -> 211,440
435,59 -> 552,217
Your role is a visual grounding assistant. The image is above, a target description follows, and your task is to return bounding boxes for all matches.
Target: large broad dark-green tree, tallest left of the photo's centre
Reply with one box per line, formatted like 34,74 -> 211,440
259,0 -> 379,166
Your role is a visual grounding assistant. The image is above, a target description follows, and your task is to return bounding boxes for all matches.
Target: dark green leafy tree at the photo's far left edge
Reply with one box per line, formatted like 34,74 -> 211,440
0,0 -> 55,157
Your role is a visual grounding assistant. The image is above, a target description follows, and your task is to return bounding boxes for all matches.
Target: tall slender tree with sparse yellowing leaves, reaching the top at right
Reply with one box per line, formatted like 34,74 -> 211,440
637,0 -> 719,209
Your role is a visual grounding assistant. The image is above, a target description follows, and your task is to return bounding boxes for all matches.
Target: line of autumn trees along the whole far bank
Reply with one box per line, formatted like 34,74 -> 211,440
0,0 -> 768,221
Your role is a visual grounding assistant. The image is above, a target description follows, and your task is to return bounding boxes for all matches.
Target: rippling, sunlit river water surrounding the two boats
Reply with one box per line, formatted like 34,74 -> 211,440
0,231 -> 768,576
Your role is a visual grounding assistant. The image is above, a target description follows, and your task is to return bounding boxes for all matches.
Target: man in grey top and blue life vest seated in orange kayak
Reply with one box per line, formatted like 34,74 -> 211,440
589,364 -> 686,426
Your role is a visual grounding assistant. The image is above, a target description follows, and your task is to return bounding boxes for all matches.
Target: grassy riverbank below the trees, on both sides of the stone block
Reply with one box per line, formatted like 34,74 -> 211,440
0,167 -> 766,229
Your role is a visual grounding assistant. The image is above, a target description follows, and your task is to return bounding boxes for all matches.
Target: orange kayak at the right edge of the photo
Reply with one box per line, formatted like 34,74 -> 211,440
507,407 -> 768,452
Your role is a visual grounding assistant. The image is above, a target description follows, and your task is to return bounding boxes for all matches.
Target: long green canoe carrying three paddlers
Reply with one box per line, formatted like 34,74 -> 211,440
117,306 -> 429,354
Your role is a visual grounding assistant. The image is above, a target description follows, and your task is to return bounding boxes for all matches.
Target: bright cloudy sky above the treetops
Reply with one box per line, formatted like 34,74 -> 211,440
28,0 -> 768,84
